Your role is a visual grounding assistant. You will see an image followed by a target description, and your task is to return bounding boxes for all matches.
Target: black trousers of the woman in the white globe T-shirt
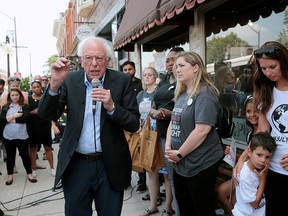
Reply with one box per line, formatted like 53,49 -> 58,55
265,170 -> 288,216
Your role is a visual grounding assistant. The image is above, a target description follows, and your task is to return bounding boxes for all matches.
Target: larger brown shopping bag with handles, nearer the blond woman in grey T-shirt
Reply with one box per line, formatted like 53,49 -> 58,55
140,115 -> 165,172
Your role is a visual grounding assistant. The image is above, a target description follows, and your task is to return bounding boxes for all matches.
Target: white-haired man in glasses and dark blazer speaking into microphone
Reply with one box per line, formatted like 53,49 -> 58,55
38,37 -> 140,216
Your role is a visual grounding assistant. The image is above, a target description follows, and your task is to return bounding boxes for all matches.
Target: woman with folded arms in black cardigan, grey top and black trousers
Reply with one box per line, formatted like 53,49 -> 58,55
0,88 -> 37,185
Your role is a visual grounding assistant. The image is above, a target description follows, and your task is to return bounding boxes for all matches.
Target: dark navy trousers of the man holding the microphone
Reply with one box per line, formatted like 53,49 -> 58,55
62,156 -> 124,216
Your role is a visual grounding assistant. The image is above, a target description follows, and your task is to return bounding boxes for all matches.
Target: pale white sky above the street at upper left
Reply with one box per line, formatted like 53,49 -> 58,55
0,0 -> 69,77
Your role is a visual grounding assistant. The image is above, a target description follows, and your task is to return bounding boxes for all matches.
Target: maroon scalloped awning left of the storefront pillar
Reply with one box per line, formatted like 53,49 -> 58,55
114,0 -> 205,50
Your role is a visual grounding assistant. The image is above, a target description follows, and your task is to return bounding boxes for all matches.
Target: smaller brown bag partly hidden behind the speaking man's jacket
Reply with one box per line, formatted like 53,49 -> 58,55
124,131 -> 144,172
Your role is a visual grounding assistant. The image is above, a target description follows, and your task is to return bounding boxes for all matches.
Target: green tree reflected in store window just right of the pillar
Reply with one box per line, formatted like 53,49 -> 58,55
207,32 -> 249,64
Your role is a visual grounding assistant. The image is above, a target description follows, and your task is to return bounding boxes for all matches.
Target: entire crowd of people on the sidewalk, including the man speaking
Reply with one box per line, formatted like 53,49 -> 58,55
0,37 -> 288,216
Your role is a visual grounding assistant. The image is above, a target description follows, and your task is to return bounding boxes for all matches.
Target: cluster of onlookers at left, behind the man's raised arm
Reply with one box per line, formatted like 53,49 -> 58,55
0,75 -> 63,186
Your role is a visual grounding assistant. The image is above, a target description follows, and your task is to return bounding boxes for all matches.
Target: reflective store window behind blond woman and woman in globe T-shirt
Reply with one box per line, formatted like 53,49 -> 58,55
206,7 -> 288,143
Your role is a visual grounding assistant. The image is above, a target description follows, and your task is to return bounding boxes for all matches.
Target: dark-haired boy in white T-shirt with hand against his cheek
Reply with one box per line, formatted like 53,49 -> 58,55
232,132 -> 276,216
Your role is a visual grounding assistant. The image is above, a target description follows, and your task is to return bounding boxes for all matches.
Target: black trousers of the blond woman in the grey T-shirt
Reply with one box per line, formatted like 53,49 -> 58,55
173,163 -> 219,216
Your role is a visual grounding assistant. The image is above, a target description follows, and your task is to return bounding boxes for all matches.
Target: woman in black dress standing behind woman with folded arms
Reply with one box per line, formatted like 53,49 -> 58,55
28,80 -> 55,177
